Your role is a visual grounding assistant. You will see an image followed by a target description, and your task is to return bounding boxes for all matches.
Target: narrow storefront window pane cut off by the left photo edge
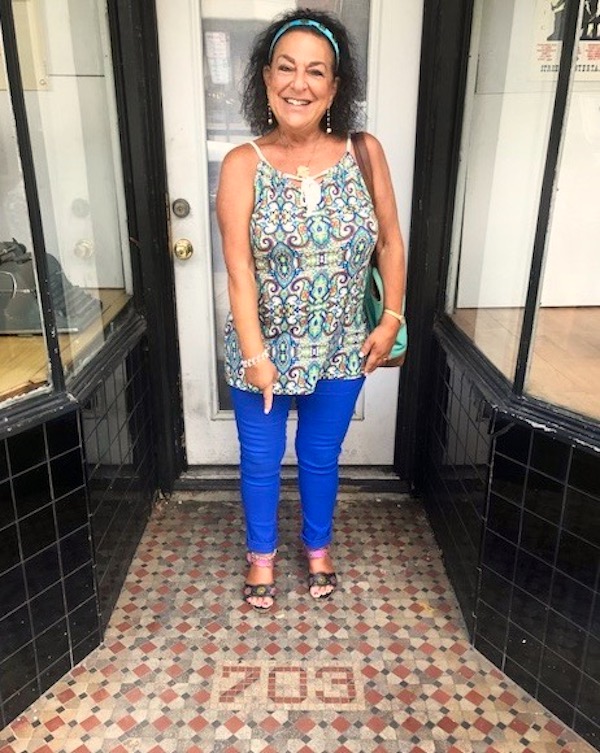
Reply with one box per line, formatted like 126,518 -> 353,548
0,27 -> 50,401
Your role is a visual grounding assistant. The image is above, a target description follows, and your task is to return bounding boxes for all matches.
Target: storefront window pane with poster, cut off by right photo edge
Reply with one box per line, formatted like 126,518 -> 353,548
525,36 -> 600,419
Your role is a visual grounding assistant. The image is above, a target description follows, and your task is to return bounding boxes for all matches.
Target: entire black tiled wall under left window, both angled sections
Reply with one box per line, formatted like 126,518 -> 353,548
0,346 -> 156,729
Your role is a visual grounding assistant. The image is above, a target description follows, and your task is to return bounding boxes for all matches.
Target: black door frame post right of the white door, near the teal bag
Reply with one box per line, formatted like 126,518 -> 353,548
394,0 -> 474,488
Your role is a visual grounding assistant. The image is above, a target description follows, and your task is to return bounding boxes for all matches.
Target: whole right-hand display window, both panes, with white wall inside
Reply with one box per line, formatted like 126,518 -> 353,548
447,0 -> 600,419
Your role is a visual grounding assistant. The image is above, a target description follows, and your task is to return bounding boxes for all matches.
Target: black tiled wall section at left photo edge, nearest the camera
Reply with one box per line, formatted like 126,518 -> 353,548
0,410 -> 100,728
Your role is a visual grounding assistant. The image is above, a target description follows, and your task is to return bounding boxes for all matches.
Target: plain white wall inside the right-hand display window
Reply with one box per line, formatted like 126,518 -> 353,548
457,0 -> 600,308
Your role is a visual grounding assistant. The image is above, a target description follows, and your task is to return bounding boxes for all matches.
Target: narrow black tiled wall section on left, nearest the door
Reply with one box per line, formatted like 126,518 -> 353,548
82,340 -> 156,630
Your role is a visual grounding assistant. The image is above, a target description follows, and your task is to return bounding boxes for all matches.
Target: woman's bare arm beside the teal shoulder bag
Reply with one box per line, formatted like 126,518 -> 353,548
362,134 -> 406,374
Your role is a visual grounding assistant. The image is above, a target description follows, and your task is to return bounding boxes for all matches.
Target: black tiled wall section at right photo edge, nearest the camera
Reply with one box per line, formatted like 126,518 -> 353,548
475,414 -> 600,747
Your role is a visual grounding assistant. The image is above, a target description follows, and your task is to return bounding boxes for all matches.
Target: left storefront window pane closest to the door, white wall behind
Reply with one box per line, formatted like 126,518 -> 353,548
5,0 -> 132,376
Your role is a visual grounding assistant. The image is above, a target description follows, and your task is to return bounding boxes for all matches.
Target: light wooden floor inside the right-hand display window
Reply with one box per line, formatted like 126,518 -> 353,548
452,307 -> 600,419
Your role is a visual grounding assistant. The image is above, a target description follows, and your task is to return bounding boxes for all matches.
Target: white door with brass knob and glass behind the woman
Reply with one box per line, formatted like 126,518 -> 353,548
156,0 -> 422,465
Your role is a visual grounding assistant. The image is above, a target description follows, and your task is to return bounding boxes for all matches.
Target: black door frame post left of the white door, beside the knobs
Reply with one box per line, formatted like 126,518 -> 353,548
108,0 -> 187,493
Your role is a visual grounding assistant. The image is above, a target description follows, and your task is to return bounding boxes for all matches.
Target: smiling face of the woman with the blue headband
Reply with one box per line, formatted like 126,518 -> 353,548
263,31 -> 337,133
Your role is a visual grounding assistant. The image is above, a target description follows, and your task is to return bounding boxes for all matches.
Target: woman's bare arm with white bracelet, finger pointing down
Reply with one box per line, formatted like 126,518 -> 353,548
217,145 -> 277,413
